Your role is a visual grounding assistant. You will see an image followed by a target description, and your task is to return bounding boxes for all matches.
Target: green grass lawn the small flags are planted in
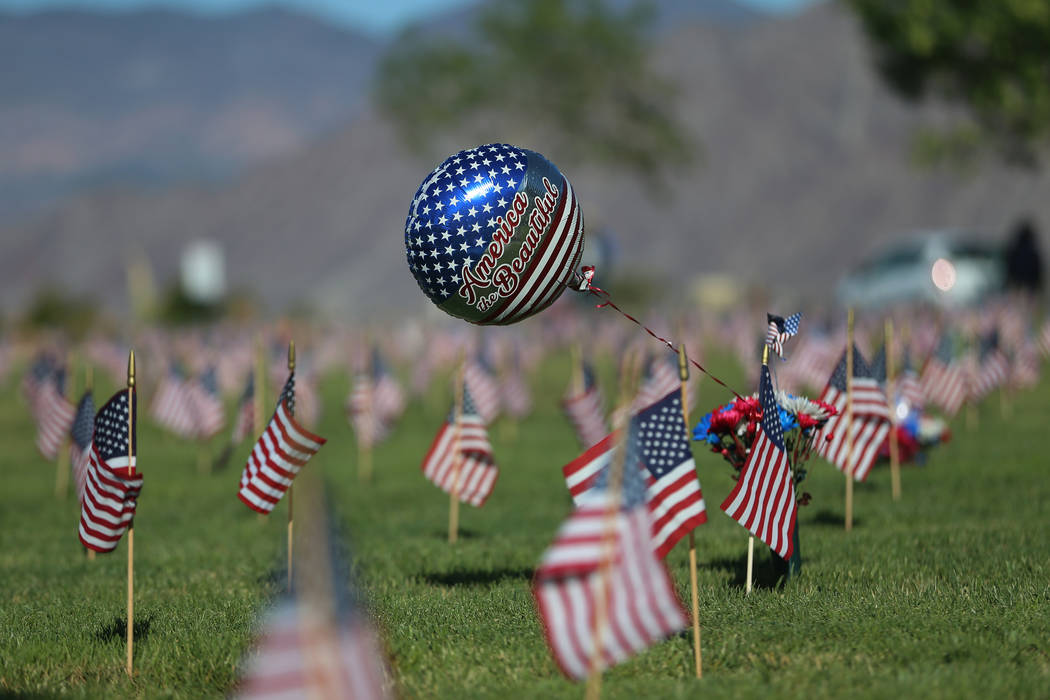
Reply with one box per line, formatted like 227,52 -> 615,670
0,350 -> 1050,698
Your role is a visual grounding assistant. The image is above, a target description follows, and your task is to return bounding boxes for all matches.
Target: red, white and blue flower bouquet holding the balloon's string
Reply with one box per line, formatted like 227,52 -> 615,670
693,391 -> 838,506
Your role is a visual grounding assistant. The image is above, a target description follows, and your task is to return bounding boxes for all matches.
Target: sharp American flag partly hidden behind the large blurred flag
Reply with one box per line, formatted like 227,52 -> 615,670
562,389 -> 708,557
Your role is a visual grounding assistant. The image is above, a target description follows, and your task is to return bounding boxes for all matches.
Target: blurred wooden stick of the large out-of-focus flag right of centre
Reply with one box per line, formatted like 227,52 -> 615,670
584,371 -> 635,700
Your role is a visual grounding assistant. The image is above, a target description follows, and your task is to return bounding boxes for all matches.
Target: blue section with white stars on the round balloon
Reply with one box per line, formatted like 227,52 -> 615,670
404,144 -> 528,304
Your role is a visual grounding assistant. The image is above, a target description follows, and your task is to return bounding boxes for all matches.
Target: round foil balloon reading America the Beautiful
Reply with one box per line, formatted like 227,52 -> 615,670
404,144 -> 584,325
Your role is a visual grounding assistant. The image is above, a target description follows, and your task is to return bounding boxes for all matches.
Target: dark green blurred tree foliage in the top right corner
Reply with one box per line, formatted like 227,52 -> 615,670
845,0 -> 1050,166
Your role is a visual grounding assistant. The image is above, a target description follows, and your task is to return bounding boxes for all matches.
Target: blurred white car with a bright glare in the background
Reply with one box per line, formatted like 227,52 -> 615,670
838,231 -> 1005,307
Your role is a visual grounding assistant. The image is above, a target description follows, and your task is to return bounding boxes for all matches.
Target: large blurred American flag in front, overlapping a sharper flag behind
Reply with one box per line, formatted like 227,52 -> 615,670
532,445 -> 689,680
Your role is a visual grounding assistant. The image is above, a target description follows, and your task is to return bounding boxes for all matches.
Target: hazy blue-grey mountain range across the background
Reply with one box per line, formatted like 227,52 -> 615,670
0,0 -> 1050,316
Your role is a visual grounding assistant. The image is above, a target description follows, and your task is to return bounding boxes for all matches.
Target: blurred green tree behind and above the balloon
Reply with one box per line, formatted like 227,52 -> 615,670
375,0 -> 693,186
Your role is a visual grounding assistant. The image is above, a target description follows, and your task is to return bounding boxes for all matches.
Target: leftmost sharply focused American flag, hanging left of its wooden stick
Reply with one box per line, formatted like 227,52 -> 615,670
79,389 -> 142,552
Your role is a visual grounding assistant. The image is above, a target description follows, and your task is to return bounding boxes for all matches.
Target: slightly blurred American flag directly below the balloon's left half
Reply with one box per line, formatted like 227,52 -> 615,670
422,382 -> 500,507
